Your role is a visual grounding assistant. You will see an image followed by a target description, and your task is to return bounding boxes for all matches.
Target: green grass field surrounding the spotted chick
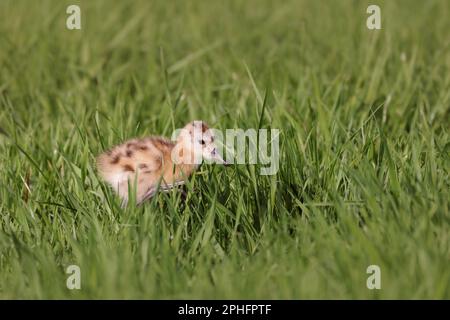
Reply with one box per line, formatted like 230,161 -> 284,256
0,0 -> 450,299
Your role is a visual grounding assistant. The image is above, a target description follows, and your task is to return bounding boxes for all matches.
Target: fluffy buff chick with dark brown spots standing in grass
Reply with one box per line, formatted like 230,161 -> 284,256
97,121 -> 227,205
